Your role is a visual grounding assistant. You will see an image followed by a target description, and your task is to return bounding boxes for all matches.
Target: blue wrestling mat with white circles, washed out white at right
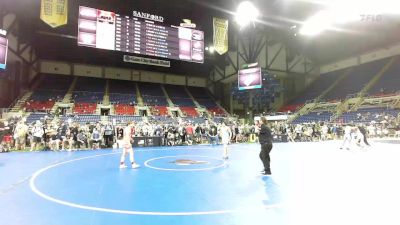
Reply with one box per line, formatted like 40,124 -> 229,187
0,142 -> 400,225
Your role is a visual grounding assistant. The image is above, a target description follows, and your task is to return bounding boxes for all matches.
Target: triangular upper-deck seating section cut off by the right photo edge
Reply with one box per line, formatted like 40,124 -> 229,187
368,60 -> 400,96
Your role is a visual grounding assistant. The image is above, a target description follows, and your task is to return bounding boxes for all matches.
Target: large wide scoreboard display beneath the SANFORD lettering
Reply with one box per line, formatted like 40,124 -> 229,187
78,6 -> 204,63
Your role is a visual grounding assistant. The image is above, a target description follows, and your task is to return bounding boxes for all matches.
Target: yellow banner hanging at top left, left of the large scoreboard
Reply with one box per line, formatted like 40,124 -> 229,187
40,0 -> 68,28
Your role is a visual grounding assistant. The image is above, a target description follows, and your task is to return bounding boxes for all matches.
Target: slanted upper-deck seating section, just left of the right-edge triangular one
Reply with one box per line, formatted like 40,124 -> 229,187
325,59 -> 389,101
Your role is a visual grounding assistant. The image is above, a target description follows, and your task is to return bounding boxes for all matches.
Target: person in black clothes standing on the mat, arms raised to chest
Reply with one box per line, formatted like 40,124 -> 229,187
258,117 -> 272,175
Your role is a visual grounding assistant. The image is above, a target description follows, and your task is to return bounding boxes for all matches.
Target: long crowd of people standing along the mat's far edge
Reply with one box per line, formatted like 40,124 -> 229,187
0,111 -> 400,151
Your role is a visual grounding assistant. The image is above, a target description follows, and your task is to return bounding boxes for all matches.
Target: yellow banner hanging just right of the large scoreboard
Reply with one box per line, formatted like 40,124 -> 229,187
213,18 -> 229,55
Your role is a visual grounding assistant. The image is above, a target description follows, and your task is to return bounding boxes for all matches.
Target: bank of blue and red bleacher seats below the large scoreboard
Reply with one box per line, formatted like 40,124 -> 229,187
14,75 -> 231,122
